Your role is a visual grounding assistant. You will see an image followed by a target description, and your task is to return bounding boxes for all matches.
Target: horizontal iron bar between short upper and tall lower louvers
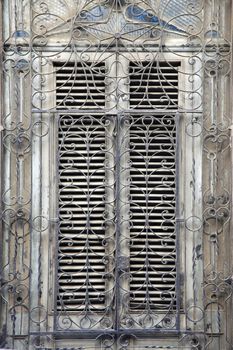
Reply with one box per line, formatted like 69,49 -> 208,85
32,108 -> 203,115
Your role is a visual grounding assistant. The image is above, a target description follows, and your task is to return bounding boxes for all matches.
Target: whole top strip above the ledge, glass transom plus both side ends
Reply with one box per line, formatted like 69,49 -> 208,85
3,0 -> 230,46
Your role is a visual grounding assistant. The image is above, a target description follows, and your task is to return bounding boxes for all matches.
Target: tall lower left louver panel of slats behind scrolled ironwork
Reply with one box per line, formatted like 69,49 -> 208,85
58,116 -> 105,311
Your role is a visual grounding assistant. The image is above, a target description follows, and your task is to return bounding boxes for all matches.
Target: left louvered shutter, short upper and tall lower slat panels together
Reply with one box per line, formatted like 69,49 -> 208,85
56,62 -> 108,311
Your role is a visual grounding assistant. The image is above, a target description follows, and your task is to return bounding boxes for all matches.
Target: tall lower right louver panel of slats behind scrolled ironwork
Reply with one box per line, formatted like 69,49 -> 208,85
130,116 -> 176,309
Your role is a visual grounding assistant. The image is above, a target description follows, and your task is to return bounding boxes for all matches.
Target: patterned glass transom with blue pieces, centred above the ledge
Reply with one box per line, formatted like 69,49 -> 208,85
29,0 -> 202,46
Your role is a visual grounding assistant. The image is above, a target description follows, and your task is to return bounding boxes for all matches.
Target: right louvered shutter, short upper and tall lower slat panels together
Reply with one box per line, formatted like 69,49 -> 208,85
129,62 -> 179,309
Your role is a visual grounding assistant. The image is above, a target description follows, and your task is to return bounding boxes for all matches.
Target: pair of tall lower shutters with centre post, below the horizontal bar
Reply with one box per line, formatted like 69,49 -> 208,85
56,113 -> 177,330
